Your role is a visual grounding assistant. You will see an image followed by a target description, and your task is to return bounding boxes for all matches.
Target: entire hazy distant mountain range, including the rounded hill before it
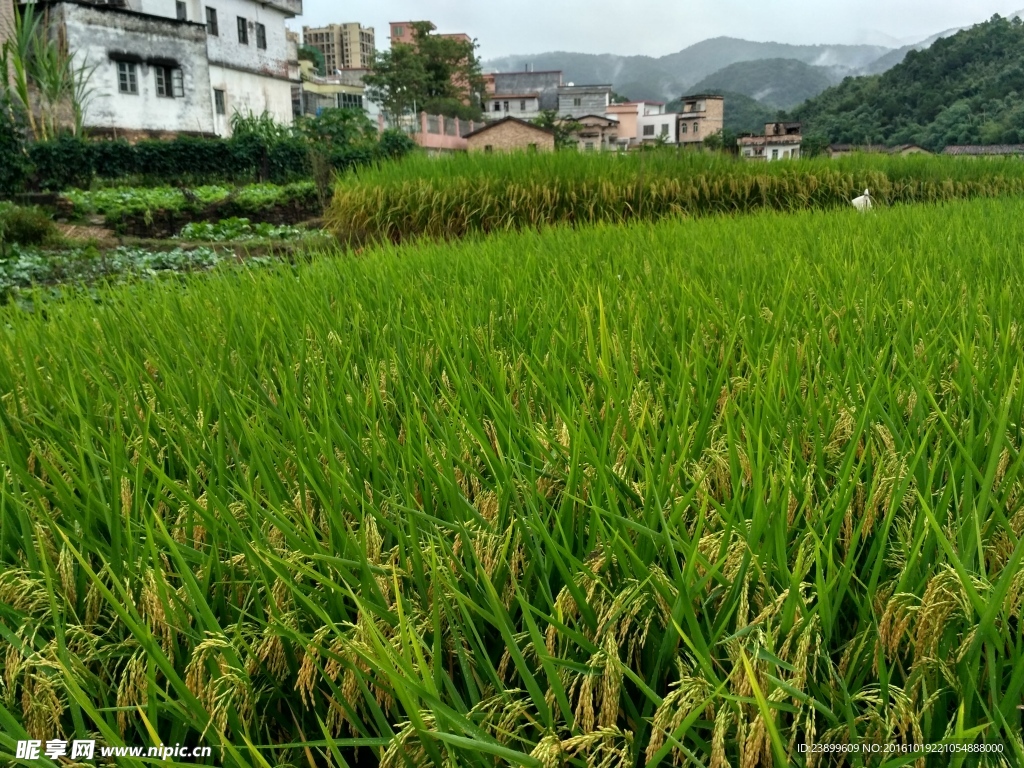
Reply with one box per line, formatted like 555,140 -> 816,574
483,11 -> 1024,110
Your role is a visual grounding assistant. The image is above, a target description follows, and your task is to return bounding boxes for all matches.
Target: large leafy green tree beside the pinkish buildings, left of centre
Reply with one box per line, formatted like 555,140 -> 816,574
364,22 -> 483,120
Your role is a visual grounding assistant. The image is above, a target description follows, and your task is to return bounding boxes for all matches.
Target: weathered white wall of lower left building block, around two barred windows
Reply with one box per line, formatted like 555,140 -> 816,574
60,3 -> 214,134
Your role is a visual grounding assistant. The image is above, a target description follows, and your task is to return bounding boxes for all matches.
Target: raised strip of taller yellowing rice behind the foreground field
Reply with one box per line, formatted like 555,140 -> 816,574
328,151 -> 1024,244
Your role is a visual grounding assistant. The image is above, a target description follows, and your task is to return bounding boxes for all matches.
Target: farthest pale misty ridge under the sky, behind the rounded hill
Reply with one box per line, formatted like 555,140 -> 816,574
483,37 -> 890,100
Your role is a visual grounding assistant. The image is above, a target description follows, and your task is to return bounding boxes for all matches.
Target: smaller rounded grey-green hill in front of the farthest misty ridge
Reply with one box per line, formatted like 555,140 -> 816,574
691,58 -> 849,110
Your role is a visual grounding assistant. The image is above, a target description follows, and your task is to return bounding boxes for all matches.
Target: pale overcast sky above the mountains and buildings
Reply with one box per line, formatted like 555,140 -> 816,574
292,0 -> 1024,59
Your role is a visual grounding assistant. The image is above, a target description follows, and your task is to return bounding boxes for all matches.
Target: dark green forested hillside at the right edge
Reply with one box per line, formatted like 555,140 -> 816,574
792,16 -> 1024,152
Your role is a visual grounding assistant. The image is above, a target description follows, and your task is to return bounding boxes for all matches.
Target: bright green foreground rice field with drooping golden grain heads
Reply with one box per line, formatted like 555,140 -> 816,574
0,199 -> 1024,768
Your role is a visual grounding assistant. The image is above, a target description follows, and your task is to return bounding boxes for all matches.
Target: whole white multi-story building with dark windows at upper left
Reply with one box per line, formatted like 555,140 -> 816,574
32,0 -> 302,137
